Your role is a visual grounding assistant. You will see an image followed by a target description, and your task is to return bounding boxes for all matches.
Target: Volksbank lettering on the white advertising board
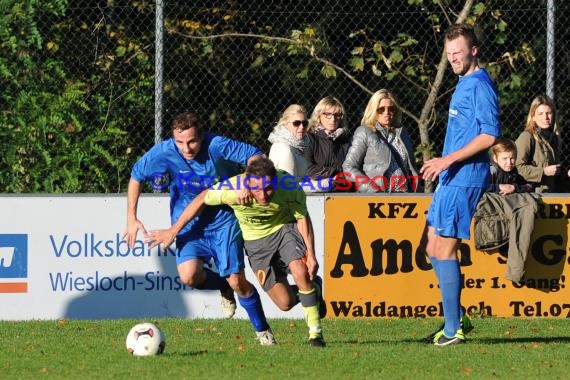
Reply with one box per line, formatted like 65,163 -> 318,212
49,233 -> 176,258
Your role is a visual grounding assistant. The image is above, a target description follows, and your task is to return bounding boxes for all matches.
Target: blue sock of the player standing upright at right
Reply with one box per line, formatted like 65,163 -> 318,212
432,260 -> 461,337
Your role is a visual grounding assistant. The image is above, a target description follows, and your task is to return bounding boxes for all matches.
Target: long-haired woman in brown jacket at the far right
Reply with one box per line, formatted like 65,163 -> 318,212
516,95 -> 570,193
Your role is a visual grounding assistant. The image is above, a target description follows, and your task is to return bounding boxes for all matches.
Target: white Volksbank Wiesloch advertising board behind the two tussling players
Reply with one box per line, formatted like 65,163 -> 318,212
0,195 -> 324,320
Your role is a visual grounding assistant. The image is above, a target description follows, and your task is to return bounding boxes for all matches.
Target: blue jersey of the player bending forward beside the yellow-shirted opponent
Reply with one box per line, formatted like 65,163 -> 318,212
131,133 -> 263,236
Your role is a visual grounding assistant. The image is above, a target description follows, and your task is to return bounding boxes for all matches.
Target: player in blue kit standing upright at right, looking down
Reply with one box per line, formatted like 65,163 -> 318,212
420,24 -> 500,346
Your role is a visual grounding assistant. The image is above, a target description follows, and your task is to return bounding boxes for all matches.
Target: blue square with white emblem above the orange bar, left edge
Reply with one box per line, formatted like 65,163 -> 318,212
0,234 -> 28,278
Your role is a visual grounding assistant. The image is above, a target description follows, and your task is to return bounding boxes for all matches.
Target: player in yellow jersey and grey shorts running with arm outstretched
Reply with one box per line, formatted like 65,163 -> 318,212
146,158 -> 325,347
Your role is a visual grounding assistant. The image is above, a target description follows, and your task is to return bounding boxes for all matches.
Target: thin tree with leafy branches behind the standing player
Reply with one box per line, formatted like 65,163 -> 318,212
170,0 -> 534,189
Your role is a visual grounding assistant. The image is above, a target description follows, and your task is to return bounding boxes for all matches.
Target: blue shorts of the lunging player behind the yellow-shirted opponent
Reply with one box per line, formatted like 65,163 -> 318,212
176,218 -> 245,277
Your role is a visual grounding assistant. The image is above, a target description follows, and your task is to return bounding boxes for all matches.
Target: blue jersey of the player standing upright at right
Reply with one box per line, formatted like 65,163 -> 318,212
439,69 -> 501,188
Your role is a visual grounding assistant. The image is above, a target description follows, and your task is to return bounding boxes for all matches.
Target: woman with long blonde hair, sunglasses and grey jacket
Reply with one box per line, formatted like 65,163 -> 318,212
342,89 -> 419,193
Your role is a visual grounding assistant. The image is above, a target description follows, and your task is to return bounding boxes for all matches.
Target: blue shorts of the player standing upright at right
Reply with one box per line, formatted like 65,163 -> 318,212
427,185 -> 485,239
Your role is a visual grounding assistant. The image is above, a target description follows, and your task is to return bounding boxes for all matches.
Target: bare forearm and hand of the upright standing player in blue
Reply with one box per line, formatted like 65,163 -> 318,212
420,133 -> 497,181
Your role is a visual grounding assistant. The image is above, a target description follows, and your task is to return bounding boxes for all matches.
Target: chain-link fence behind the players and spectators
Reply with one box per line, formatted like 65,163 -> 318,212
0,0 -> 570,192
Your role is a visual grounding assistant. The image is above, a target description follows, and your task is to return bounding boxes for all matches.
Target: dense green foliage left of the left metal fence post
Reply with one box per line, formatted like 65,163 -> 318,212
0,0 -> 152,193
